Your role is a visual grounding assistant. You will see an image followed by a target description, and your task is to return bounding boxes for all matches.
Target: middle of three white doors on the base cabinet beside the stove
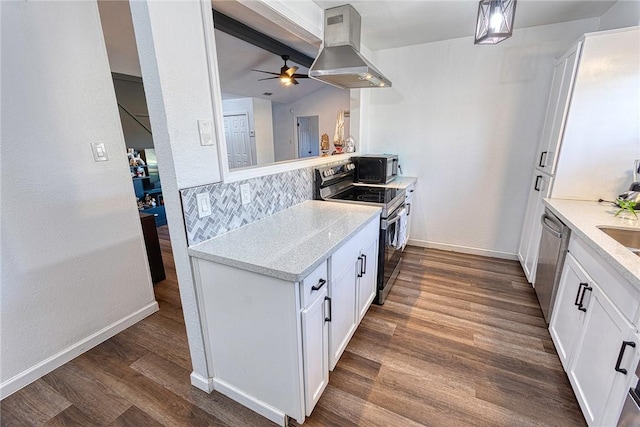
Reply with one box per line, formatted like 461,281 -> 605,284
329,257 -> 360,370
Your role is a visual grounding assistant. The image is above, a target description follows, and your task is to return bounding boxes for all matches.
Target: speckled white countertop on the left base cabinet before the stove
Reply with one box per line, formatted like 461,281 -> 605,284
188,200 -> 381,282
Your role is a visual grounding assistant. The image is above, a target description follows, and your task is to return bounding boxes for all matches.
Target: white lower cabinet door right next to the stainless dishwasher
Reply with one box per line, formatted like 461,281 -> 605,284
549,253 -> 593,371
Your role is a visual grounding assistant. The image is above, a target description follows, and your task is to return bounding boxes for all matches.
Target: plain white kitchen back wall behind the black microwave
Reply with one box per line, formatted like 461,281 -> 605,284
364,19 -> 599,258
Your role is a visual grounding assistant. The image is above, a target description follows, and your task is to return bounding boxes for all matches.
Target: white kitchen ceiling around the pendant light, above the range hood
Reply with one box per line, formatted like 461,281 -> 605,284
314,0 -> 616,50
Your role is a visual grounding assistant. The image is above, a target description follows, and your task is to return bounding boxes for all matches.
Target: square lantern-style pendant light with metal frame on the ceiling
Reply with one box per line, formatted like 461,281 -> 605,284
475,0 -> 516,44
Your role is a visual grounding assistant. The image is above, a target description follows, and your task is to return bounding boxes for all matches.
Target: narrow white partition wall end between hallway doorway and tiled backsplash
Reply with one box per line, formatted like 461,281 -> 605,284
130,0 -> 226,391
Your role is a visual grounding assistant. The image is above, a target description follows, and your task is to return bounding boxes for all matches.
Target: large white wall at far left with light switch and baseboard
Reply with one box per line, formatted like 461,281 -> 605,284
0,1 -> 157,397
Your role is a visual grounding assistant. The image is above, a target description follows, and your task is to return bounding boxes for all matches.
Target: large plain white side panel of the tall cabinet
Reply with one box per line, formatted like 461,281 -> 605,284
552,27 -> 640,200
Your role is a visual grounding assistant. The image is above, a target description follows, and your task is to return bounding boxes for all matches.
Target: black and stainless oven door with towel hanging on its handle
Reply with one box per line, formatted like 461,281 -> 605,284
376,205 -> 404,304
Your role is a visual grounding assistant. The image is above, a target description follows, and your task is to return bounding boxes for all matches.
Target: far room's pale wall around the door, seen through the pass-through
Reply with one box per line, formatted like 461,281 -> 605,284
273,85 -> 350,161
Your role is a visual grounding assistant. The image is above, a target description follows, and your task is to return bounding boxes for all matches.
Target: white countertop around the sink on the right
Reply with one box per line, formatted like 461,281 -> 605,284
544,199 -> 640,290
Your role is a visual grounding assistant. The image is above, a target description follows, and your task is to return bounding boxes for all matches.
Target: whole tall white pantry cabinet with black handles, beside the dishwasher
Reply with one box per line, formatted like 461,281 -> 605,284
518,27 -> 640,283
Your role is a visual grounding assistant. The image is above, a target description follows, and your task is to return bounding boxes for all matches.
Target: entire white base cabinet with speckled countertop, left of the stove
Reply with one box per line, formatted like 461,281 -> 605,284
189,200 -> 381,426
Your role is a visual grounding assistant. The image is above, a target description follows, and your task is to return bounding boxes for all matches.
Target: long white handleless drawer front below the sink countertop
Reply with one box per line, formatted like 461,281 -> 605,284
569,235 -> 640,322
